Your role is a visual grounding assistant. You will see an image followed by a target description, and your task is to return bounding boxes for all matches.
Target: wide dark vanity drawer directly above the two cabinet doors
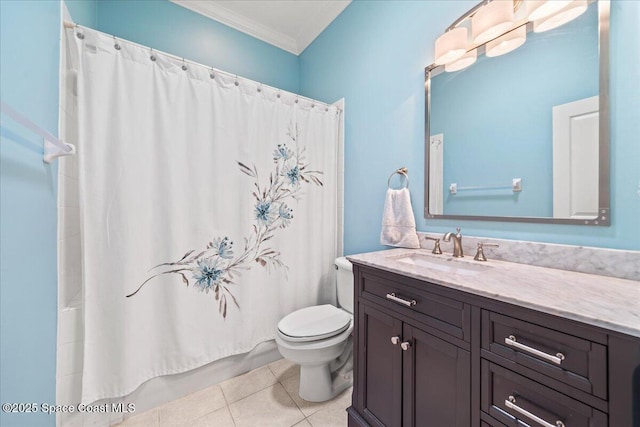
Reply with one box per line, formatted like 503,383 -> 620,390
358,273 -> 470,341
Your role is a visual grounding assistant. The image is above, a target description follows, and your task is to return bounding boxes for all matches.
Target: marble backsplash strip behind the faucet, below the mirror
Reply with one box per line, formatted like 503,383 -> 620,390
418,230 -> 640,281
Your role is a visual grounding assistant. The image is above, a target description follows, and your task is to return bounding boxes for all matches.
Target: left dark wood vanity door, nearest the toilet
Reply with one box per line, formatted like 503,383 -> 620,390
357,303 -> 403,427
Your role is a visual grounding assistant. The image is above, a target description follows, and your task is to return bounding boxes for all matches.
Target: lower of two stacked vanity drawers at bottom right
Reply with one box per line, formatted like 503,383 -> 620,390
480,360 -> 608,427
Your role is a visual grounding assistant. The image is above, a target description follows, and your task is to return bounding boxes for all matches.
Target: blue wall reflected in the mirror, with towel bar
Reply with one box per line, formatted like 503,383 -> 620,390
430,3 -> 599,217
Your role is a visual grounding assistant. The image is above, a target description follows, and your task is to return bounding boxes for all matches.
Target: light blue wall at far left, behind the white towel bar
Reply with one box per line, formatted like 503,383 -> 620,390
0,1 -> 60,426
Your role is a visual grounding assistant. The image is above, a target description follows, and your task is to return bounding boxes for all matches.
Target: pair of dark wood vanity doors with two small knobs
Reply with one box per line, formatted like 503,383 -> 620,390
356,303 -> 470,427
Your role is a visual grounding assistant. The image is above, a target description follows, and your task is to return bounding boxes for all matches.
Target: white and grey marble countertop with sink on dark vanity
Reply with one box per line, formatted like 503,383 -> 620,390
347,249 -> 640,338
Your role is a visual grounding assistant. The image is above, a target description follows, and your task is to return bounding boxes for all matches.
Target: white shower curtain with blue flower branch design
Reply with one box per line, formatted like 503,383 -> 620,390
60,28 -> 340,403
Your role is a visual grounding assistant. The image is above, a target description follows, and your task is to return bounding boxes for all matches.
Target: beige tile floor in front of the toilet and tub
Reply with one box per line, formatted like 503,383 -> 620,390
118,359 -> 351,427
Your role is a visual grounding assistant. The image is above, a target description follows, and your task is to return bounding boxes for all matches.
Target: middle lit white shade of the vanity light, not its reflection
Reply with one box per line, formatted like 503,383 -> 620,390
471,0 -> 514,45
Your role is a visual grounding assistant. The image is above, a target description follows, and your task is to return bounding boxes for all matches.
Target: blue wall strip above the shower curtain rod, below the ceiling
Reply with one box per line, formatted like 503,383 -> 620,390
97,0 -> 298,92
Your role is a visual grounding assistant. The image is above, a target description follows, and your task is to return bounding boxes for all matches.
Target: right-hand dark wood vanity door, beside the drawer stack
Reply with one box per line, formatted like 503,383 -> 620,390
402,323 -> 470,427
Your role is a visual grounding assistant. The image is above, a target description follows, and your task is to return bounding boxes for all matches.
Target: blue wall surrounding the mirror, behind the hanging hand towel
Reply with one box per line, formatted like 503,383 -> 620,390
300,0 -> 640,254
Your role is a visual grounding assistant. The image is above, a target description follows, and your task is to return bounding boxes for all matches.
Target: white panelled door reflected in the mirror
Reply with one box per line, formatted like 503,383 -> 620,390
553,96 -> 599,219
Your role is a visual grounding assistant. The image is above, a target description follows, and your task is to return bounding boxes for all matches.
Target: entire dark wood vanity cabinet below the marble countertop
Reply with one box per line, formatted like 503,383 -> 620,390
348,263 -> 640,427
